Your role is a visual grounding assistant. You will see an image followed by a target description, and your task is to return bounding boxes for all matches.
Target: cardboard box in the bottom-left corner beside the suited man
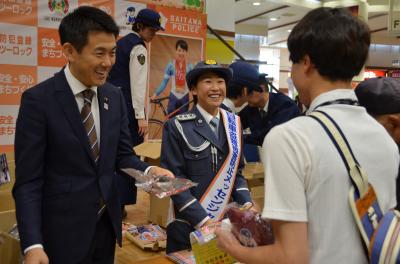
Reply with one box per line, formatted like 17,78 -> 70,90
0,210 -> 22,264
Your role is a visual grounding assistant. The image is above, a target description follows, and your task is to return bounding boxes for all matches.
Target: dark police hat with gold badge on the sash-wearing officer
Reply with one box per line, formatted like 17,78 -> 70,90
186,60 -> 232,89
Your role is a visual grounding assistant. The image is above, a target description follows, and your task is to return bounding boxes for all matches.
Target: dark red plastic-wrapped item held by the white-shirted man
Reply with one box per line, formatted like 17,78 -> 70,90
226,203 -> 275,247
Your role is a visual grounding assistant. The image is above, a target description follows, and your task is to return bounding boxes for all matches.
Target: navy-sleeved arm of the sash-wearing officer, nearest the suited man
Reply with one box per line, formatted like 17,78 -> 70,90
161,120 -> 208,227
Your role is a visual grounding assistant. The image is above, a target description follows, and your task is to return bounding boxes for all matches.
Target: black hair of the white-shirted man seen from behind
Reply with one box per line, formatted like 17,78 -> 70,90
287,7 -> 371,81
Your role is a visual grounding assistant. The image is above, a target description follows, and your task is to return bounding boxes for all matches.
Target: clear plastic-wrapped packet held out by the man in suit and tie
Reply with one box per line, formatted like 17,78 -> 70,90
121,168 -> 197,198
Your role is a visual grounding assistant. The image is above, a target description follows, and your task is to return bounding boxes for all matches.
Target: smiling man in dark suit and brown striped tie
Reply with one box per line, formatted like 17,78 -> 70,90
13,6 -> 172,264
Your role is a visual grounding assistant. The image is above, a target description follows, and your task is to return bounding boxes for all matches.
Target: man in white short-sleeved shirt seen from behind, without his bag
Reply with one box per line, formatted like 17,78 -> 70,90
217,7 -> 399,264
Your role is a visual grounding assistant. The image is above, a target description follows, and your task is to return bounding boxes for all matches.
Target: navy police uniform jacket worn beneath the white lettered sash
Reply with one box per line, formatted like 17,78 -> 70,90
161,107 -> 251,252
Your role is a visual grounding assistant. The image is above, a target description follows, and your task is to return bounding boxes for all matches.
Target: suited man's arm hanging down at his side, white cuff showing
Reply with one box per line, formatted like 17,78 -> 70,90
12,88 -> 47,260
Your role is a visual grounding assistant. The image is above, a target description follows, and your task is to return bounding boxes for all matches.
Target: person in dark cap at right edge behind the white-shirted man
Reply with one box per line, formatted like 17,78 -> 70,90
355,77 -> 400,209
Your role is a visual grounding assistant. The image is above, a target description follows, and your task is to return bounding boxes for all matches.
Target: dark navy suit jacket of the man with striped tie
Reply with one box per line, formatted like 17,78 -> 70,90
13,71 -> 148,263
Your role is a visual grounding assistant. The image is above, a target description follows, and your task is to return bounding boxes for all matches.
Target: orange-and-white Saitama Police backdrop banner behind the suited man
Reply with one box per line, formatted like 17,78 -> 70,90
0,0 -> 206,153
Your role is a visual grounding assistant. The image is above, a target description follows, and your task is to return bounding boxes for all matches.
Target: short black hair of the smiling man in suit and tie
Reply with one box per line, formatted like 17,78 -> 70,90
58,6 -> 119,52
